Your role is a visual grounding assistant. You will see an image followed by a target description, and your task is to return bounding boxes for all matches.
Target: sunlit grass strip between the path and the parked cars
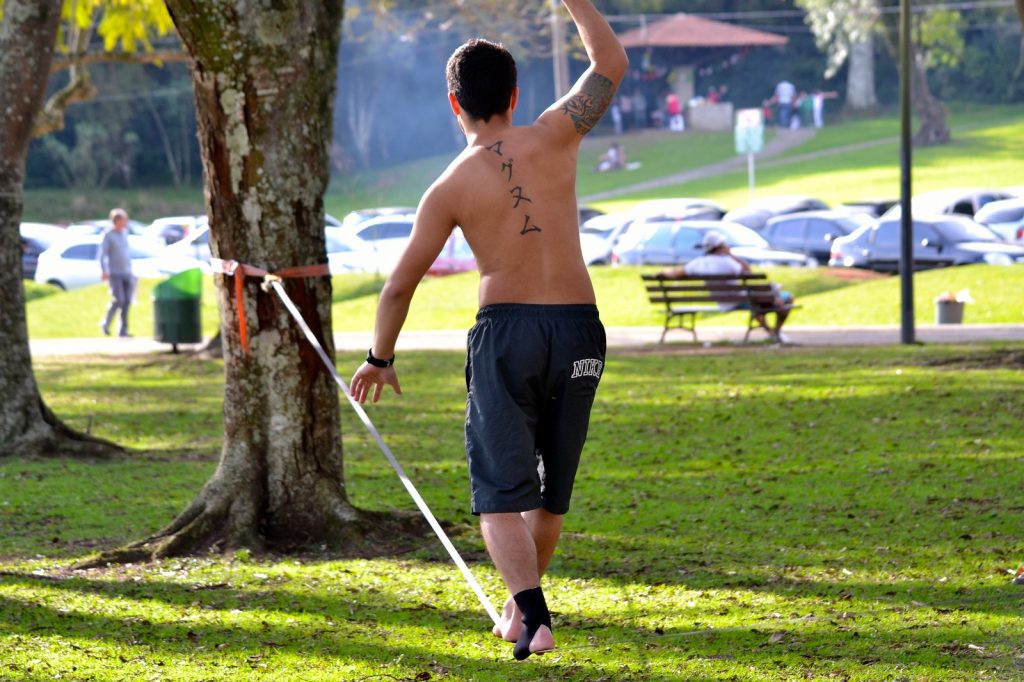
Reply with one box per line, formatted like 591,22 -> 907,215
26,265 -> 1024,339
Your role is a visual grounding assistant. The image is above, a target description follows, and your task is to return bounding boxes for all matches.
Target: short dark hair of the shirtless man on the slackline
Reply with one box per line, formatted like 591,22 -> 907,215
446,39 -> 516,122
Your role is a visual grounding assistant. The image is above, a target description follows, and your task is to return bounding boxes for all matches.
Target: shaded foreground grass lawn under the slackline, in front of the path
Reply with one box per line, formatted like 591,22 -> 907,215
0,344 -> 1024,681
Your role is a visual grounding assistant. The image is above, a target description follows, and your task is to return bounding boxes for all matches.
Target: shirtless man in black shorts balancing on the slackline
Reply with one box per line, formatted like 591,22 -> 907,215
350,0 -> 628,659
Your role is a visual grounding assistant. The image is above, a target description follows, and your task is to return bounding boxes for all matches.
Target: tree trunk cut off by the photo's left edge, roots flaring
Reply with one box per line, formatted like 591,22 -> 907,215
0,0 -> 119,457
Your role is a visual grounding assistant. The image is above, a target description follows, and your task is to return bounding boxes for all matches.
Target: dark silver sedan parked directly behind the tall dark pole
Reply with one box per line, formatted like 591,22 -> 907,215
828,215 -> 1024,272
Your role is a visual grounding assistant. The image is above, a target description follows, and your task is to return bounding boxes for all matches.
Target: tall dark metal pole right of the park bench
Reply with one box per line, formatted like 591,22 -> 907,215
899,0 -> 914,344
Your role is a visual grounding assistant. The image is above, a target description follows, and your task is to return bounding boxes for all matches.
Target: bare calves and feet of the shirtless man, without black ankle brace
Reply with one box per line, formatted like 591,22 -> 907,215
480,510 -> 561,653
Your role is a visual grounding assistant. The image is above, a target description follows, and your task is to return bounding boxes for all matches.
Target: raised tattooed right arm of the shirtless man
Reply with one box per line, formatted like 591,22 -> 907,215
538,0 -> 629,137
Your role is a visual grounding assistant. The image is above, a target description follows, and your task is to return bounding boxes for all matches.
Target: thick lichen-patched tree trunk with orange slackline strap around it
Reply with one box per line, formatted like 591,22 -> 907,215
77,0 -> 419,565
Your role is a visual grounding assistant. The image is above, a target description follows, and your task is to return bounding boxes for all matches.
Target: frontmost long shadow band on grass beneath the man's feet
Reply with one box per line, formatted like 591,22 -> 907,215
0,573 -> 1012,680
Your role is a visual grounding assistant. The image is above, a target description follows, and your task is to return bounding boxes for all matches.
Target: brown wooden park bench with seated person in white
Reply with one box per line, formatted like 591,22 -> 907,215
641,272 -> 800,343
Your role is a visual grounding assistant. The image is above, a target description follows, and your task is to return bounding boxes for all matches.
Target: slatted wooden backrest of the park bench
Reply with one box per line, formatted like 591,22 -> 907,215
641,272 -> 775,306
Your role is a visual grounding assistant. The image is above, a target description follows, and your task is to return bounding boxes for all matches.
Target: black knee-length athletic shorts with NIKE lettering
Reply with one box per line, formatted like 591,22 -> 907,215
466,303 -> 606,514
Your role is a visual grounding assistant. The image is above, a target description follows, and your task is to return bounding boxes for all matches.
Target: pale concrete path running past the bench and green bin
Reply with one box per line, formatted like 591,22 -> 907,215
30,325 -> 1024,357
